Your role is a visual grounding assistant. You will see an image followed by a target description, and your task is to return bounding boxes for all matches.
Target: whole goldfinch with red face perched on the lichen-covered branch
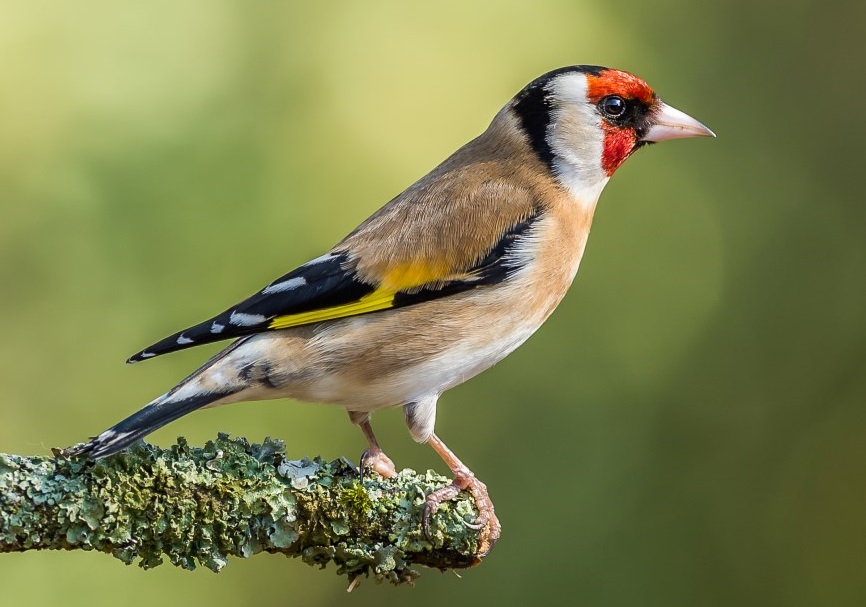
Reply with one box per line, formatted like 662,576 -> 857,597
64,65 -> 715,553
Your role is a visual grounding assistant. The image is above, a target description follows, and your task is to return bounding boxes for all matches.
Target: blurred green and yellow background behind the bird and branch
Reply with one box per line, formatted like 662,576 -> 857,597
0,0 -> 866,607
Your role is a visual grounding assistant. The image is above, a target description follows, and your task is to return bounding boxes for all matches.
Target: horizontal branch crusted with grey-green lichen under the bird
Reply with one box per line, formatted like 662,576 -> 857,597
0,435 -> 482,584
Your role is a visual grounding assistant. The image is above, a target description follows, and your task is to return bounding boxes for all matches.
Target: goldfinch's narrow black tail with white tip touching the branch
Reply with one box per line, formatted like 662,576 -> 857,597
63,391 -> 231,459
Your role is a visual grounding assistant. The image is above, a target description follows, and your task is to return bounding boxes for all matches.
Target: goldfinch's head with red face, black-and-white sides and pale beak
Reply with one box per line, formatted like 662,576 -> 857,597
508,65 -> 715,200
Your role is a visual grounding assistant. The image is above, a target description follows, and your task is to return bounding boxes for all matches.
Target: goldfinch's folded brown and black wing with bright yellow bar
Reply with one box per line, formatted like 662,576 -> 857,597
128,164 -> 541,362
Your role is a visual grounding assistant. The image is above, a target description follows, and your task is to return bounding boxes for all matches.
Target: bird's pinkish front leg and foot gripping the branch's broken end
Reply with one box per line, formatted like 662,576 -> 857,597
421,434 -> 502,556
